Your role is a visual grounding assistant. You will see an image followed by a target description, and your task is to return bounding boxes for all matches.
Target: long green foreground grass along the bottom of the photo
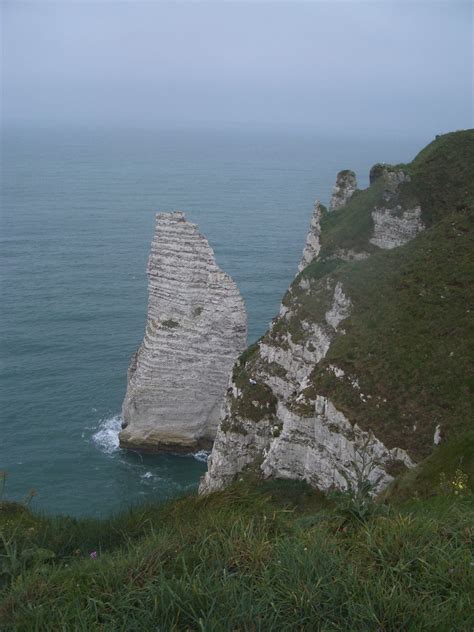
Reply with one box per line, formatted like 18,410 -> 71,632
0,483 -> 474,632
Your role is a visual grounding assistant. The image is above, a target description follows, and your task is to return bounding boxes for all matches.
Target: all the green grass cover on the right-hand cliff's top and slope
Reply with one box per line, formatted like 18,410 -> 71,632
274,130 -> 474,460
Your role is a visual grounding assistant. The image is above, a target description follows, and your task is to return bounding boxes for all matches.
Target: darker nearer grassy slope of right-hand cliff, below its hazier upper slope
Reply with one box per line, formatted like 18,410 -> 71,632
312,208 -> 474,460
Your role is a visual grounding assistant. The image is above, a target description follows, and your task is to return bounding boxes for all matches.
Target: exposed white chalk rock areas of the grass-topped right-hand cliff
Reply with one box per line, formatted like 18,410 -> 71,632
200,169 -> 423,493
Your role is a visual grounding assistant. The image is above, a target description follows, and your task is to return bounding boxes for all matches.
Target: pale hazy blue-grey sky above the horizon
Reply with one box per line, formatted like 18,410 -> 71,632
2,0 -> 473,134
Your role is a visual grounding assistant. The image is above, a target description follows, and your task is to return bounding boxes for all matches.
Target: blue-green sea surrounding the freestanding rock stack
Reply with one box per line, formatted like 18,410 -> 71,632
0,129 -> 430,516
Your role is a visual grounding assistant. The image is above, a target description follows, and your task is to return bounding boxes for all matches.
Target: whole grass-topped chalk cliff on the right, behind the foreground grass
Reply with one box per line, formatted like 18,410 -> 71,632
200,132 -> 474,493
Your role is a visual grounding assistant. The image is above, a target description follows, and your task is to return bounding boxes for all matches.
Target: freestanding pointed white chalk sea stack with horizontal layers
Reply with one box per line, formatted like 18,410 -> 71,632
120,212 -> 247,452
